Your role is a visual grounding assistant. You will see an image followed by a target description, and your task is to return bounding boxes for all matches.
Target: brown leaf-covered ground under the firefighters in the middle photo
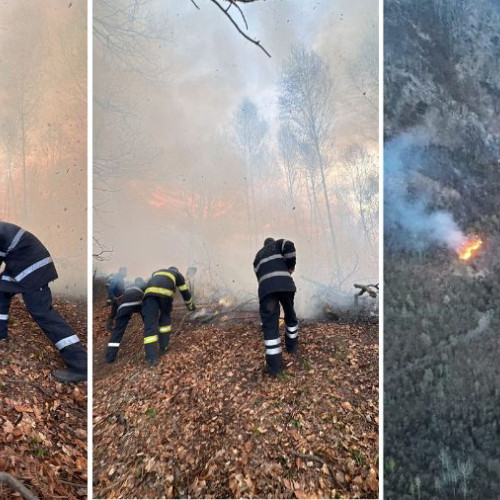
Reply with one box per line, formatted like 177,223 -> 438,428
94,305 -> 378,498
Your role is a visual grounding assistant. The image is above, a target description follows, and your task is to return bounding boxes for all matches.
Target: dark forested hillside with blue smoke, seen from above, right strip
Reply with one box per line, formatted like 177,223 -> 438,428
384,0 -> 500,499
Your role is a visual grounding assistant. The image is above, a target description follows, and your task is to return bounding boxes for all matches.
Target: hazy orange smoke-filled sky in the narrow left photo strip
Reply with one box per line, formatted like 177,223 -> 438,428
0,0 -> 87,295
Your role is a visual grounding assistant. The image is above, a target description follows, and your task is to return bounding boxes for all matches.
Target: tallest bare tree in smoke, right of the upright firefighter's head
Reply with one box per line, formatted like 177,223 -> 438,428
279,47 -> 340,277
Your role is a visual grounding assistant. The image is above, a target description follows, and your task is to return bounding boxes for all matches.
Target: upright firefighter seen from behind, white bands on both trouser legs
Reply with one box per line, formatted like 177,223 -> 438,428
253,238 -> 299,376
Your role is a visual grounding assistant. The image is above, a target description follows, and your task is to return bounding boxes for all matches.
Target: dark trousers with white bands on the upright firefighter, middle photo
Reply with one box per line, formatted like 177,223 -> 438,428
259,292 -> 299,374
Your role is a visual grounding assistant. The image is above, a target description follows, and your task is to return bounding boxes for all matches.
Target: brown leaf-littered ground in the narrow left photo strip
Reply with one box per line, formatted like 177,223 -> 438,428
0,296 -> 87,499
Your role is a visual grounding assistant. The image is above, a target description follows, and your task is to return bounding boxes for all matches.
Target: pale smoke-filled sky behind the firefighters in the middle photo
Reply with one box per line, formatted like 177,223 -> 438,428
94,1 -> 378,315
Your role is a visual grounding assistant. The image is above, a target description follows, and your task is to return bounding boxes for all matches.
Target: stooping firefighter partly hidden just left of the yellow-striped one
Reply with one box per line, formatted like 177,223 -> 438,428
106,278 -> 146,363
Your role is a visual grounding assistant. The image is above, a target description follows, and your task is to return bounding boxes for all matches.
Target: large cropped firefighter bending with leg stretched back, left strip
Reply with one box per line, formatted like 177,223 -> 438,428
0,221 -> 87,382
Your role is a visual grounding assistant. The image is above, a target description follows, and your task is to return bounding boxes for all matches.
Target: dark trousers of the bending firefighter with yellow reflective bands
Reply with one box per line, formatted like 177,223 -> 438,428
142,295 -> 173,363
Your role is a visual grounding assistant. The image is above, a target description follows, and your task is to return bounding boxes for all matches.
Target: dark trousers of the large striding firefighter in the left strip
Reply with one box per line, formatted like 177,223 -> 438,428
0,285 -> 87,373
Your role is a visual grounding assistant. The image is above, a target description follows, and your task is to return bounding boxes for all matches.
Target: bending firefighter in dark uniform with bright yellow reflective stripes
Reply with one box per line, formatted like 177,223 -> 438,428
142,267 -> 195,366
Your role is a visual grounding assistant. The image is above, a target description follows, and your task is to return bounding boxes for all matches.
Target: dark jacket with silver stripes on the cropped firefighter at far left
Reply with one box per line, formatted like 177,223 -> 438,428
0,221 -> 57,293
